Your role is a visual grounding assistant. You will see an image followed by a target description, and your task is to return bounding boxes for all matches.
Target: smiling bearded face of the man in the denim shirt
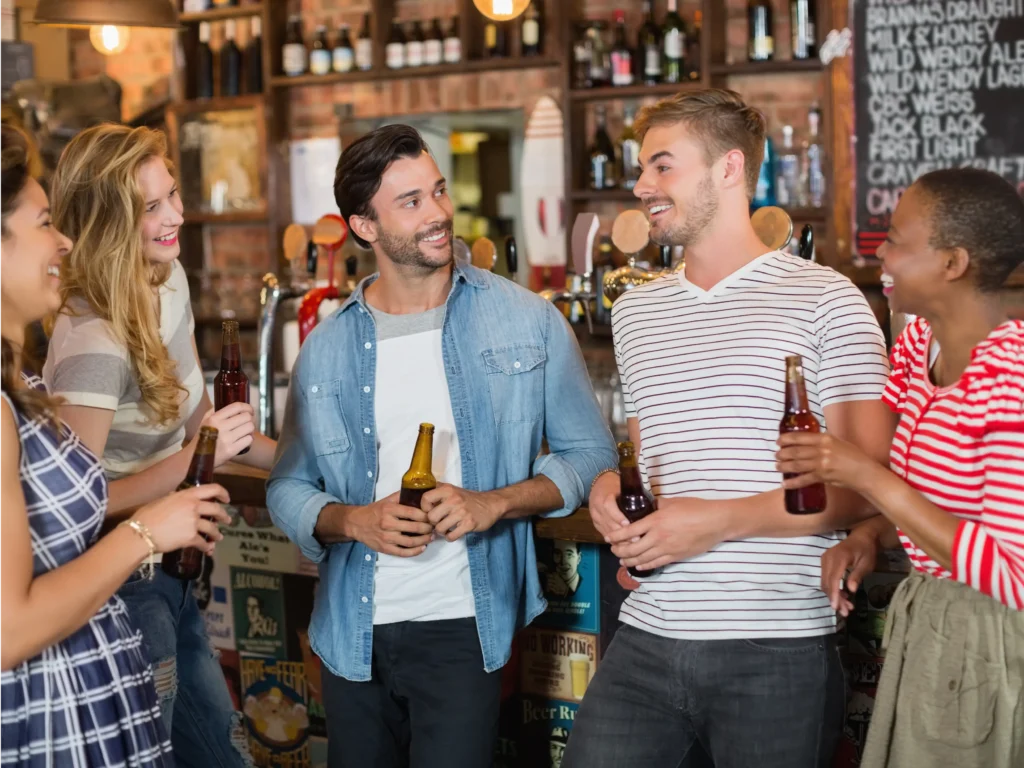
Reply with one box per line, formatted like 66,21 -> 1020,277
351,152 -> 454,272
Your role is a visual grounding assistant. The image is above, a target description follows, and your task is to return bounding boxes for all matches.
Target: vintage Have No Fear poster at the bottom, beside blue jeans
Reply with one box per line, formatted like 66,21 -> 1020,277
242,656 -> 309,768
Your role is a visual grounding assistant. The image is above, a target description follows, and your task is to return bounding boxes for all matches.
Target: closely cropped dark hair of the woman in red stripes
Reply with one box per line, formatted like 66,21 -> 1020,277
913,168 -> 1024,293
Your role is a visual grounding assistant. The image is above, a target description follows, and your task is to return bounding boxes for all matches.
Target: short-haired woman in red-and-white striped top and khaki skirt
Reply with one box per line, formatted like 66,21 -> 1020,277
778,169 -> 1024,768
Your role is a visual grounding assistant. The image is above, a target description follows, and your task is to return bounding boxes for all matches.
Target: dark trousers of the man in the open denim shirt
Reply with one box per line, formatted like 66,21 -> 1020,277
323,618 -> 502,768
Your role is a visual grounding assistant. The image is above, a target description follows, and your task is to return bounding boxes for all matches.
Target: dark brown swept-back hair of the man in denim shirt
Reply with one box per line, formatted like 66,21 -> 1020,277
334,125 -> 429,248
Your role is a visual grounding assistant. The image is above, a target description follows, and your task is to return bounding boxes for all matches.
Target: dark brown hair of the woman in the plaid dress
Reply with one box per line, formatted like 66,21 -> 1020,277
0,125 -> 57,426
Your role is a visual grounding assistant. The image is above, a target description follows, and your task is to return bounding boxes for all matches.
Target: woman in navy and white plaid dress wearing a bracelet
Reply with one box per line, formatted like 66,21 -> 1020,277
0,127 -> 228,768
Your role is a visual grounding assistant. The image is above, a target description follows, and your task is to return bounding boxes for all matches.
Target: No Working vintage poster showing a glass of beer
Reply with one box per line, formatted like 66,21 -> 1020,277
519,628 -> 597,701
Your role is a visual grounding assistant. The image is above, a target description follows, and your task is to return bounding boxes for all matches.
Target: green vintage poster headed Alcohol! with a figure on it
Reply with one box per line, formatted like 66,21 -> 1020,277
230,567 -> 287,659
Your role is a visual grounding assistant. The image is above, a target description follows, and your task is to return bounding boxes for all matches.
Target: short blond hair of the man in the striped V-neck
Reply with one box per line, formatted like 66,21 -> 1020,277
635,88 -> 768,199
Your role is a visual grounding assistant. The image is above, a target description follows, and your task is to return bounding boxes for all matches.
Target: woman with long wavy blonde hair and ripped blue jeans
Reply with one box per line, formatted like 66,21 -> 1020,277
43,125 -> 274,768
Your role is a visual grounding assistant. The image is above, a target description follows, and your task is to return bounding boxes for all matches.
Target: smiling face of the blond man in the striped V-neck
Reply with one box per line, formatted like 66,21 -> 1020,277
633,123 -> 720,247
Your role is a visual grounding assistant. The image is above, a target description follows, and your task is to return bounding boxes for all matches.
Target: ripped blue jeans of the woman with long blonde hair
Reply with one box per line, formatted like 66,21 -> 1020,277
118,566 -> 253,768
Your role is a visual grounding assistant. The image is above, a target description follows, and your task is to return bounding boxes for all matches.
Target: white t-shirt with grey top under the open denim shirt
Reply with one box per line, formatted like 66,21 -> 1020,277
371,306 -> 476,624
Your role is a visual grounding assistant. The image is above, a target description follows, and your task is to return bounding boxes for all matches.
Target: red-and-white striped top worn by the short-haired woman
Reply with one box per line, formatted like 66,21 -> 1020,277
882,318 -> 1024,609
